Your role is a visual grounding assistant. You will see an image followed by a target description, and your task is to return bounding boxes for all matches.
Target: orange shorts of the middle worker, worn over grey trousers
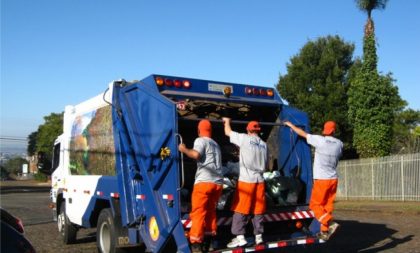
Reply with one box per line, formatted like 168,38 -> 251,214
231,181 -> 266,214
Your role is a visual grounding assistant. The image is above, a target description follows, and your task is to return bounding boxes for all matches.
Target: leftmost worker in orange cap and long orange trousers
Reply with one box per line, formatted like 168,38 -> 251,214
178,120 -> 223,252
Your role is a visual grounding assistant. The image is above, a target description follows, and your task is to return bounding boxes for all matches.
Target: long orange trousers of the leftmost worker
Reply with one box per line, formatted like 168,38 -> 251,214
190,182 -> 223,243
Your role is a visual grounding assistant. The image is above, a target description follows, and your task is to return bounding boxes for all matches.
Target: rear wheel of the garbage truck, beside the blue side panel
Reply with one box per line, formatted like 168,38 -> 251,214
96,208 -> 124,253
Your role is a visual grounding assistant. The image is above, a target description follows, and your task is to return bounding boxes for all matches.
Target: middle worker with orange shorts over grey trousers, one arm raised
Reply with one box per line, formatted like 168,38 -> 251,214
223,118 -> 268,248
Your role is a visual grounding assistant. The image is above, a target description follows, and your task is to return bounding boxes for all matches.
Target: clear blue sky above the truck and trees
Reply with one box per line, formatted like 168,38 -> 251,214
0,0 -> 420,152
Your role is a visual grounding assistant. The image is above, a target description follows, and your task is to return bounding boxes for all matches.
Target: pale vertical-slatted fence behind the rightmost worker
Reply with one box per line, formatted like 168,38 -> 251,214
337,153 -> 420,201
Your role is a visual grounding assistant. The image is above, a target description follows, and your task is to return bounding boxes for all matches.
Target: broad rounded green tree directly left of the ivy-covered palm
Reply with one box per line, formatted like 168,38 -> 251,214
277,36 -> 354,157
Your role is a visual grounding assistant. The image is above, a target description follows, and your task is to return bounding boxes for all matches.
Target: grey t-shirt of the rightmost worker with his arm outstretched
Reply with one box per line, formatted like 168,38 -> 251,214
306,134 -> 343,179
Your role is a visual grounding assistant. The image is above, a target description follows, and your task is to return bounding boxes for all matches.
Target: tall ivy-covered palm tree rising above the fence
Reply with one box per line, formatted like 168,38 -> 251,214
348,0 -> 404,157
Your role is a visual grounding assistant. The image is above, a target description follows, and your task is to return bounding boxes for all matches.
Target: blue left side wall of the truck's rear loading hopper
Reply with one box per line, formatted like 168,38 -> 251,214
113,83 -> 189,252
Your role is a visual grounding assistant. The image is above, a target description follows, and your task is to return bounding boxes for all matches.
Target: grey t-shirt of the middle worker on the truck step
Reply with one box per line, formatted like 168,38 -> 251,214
230,131 -> 267,183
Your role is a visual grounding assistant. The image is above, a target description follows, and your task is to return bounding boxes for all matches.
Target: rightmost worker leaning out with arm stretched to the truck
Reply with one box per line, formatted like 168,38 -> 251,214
284,121 -> 343,240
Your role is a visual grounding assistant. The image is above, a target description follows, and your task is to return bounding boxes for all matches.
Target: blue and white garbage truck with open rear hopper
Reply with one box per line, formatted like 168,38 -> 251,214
50,74 -> 323,253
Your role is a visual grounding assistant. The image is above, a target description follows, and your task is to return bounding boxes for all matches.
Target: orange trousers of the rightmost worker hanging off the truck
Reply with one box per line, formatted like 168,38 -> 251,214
309,179 -> 338,232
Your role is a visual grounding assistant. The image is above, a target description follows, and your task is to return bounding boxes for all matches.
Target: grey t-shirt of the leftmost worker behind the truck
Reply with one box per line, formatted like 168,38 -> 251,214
193,137 -> 223,184
